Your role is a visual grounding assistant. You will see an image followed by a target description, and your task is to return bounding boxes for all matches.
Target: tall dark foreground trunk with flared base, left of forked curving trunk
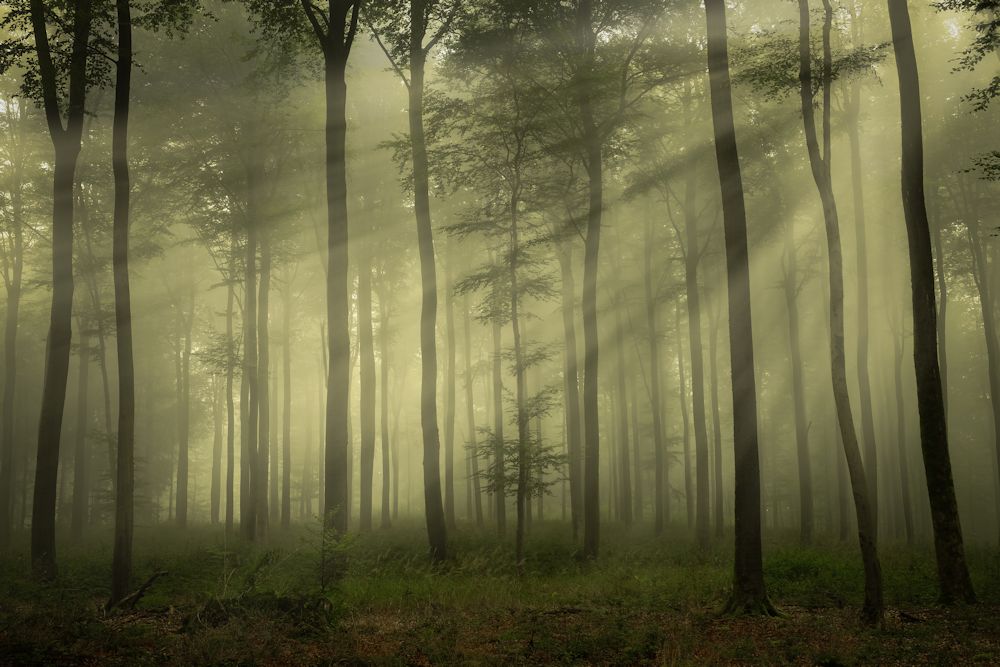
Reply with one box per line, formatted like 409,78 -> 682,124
705,0 -> 774,613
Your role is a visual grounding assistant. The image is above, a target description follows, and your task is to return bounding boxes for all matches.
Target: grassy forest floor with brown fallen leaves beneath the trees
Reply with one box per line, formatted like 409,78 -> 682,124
0,522 -> 1000,666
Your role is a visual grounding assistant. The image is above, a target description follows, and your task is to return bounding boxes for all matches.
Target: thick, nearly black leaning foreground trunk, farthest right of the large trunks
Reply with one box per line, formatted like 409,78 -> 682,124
888,0 -> 975,603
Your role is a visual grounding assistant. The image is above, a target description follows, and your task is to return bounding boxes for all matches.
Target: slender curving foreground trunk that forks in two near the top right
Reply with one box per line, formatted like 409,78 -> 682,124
799,0 -> 883,625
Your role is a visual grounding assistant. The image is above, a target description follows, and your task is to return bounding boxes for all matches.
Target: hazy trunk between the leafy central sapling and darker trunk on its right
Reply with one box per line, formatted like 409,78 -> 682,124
556,244 -> 583,541
